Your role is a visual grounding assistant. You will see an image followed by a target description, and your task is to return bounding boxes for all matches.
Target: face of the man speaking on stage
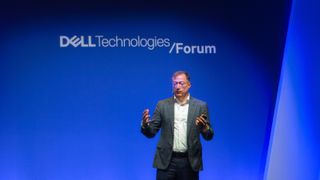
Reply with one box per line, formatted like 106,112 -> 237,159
172,74 -> 191,98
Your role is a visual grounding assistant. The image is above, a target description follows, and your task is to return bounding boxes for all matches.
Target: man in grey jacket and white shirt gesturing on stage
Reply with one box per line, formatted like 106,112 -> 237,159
141,71 -> 214,180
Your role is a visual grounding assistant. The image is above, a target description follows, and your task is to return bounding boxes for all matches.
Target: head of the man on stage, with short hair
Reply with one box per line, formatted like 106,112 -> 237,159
172,71 -> 191,99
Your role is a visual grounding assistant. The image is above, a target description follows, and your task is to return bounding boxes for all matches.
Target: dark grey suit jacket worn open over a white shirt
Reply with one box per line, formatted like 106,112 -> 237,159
141,97 -> 214,171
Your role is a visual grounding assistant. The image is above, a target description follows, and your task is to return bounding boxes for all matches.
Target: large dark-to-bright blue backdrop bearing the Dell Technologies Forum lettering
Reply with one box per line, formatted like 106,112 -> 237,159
0,0 -> 290,180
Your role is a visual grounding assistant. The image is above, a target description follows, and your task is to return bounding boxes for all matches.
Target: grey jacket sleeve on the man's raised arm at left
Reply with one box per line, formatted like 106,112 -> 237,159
141,103 -> 161,138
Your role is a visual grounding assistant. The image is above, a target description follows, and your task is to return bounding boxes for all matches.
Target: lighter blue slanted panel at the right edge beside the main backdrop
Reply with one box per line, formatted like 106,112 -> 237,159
265,0 -> 320,180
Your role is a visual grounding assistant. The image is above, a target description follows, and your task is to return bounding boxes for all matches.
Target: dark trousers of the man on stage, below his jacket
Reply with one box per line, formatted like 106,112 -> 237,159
157,154 -> 199,180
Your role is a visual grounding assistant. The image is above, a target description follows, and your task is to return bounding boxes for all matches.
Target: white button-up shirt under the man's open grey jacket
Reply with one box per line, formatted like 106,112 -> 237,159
173,95 -> 190,152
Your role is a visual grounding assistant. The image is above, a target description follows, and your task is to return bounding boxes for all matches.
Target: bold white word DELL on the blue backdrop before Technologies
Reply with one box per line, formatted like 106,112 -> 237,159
60,36 -> 96,47
